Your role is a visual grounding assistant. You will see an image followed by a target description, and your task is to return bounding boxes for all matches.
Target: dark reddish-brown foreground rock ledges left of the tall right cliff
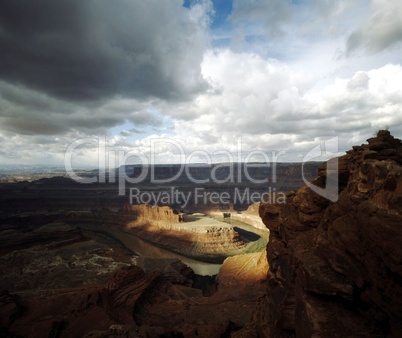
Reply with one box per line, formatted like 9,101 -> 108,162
0,260 -> 266,338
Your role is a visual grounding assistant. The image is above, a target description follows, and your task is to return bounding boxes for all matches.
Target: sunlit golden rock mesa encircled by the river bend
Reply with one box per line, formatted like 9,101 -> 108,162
125,205 -> 265,263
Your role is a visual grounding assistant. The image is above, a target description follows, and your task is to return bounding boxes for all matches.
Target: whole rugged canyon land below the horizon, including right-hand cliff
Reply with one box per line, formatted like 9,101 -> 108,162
0,130 -> 402,338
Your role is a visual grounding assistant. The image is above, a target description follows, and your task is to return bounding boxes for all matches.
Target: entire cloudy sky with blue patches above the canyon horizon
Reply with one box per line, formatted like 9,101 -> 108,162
0,0 -> 402,167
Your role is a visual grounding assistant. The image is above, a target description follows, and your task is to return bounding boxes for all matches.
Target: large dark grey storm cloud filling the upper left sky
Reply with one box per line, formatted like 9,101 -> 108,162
0,0 -> 207,101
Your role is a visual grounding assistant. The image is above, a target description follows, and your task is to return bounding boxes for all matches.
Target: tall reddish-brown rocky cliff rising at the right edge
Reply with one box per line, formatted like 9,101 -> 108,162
242,131 -> 402,337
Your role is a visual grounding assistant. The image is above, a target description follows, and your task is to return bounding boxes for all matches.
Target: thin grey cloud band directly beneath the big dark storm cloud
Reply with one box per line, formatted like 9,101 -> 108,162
0,81 -> 161,135
